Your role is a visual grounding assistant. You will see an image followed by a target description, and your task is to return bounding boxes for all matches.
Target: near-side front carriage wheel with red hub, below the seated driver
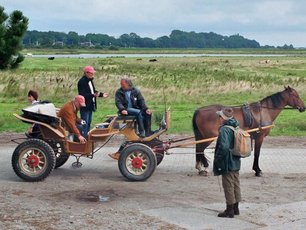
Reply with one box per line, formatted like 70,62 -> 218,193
118,143 -> 157,181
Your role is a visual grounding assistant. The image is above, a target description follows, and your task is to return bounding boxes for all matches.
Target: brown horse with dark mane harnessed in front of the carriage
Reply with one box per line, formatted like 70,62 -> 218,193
192,86 -> 305,176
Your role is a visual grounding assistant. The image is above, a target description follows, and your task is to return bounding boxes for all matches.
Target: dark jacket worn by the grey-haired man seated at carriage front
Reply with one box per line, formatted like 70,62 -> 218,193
115,87 -> 148,112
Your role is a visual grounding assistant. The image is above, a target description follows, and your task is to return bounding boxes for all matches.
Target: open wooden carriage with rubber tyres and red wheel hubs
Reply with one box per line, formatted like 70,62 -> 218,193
12,104 -> 170,181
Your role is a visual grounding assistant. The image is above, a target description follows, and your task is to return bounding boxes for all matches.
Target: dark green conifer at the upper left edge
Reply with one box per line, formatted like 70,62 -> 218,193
0,6 -> 28,69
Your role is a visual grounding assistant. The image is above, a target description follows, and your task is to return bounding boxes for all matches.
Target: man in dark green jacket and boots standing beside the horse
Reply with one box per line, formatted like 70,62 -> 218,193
213,108 -> 241,218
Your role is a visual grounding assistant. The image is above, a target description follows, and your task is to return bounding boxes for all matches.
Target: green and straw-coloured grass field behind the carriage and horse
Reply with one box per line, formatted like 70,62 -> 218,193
0,53 -> 306,136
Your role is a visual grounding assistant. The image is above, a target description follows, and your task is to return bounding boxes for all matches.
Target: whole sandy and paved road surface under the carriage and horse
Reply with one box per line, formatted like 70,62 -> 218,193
0,134 -> 306,230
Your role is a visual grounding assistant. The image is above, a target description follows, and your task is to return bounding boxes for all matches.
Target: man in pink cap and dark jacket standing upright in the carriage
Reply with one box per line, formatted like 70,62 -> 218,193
78,66 -> 108,135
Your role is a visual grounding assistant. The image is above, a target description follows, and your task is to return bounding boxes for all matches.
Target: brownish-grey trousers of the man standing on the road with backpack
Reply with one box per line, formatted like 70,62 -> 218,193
222,171 -> 241,205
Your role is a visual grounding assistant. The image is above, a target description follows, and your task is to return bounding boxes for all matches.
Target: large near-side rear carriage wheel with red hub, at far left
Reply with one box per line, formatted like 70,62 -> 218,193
12,139 -> 55,181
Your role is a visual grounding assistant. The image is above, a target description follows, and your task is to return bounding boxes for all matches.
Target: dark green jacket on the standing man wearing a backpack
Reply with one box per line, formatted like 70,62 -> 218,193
213,119 -> 241,176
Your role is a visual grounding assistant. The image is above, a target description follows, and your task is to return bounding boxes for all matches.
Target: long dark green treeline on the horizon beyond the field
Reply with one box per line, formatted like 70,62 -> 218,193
23,30 -> 268,49
